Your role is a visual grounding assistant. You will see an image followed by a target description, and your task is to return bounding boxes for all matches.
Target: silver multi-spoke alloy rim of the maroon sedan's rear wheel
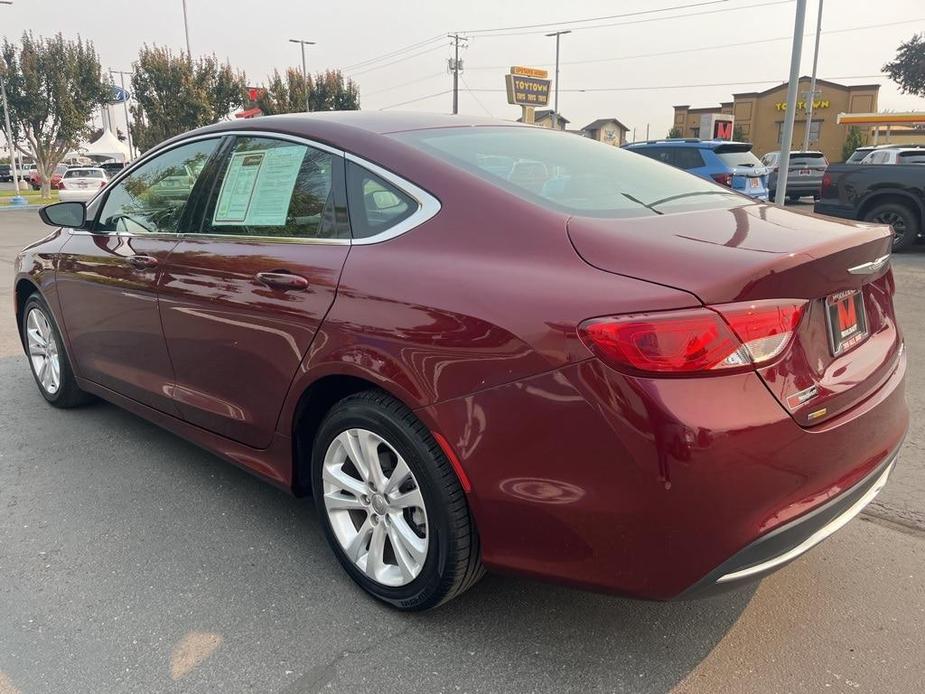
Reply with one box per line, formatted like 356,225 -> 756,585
322,429 -> 430,587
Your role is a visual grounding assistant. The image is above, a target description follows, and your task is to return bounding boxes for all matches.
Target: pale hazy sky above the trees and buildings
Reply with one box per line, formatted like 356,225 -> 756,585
0,0 -> 925,138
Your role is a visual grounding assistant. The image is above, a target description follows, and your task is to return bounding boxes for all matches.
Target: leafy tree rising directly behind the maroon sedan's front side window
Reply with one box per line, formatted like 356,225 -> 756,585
132,45 -> 247,151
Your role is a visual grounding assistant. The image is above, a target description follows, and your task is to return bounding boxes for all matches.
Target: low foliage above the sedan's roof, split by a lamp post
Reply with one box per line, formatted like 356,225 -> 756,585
254,68 -> 360,116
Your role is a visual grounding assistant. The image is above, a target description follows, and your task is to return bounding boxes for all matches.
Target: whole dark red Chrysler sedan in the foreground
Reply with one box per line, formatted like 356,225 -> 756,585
15,112 -> 908,610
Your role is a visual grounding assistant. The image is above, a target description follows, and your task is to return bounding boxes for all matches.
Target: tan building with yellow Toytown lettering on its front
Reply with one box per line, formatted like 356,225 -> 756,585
674,77 -> 880,161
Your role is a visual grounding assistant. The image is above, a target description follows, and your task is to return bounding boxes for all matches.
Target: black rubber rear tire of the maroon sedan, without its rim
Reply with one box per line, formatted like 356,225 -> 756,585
312,398 -> 451,610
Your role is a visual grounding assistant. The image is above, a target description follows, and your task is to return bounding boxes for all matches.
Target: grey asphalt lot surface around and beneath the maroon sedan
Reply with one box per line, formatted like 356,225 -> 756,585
0,210 -> 925,694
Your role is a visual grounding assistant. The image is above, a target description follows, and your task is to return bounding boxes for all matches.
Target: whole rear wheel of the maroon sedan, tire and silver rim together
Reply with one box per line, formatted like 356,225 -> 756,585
312,390 -> 484,611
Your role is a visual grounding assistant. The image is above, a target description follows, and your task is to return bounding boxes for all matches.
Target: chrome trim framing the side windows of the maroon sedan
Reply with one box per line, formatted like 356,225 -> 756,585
80,129 -> 441,246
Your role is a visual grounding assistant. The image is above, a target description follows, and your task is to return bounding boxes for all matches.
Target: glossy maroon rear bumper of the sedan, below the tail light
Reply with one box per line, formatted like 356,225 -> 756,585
418,348 -> 909,600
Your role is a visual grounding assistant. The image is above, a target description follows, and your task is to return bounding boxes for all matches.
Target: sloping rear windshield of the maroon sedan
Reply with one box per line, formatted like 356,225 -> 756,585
393,126 -> 744,217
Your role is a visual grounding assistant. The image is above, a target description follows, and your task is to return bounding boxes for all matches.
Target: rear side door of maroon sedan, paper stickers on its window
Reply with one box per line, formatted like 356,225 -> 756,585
158,135 -> 350,448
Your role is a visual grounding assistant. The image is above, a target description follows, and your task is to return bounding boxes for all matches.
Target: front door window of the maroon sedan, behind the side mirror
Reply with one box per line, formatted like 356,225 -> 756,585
96,138 -> 219,234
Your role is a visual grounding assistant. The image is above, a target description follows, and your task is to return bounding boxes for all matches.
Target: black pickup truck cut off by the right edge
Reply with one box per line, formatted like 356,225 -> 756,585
815,164 -> 925,251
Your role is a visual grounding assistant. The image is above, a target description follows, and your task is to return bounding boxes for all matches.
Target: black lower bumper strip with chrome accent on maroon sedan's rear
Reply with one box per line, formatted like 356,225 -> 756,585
678,453 -> 897,600
